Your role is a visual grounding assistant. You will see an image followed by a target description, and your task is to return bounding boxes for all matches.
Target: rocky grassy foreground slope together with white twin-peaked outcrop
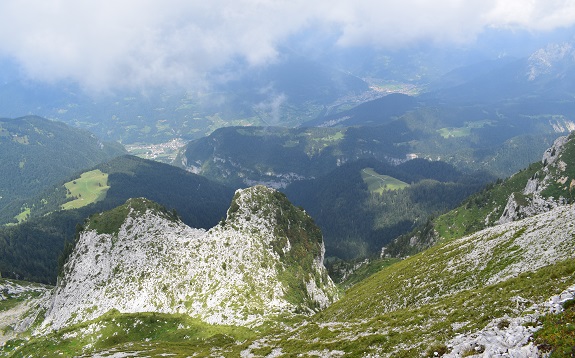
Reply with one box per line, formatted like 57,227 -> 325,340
2,137 -> 575,357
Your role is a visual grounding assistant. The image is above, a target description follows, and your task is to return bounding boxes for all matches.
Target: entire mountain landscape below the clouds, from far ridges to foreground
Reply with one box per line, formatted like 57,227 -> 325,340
0,37 -> 575,357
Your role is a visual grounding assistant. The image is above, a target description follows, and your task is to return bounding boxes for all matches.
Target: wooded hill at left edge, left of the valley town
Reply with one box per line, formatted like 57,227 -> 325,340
0,116 -> 126,210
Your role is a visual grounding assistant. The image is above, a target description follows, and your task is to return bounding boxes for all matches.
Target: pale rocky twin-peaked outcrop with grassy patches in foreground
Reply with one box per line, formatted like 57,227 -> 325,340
43,186 -> 337,329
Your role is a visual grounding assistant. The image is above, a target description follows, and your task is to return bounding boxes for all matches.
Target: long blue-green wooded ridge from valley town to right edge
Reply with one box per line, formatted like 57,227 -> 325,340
182,95 -> 575,188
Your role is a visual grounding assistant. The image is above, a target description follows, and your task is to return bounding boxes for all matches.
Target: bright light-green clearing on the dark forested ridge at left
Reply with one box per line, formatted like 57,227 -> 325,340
62,169 -> 110,210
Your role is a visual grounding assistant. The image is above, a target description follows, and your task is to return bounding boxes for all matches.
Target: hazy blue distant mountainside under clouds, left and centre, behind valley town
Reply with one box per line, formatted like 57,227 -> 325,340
0,50 -> 369,144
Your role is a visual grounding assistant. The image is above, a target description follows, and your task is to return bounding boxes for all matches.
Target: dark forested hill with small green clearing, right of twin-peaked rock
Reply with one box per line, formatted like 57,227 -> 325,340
285,159 -> 486,259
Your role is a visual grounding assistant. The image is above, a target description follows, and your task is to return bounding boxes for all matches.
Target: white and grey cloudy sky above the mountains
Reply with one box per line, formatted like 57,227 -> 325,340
0,0 -> 575,90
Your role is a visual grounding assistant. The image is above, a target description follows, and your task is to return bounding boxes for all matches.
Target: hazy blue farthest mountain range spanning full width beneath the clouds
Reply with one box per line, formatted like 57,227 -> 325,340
0,42 -> 574,150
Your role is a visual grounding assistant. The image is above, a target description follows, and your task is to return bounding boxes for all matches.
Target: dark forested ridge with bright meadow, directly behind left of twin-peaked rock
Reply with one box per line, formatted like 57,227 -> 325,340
0,155 -> 233,228
